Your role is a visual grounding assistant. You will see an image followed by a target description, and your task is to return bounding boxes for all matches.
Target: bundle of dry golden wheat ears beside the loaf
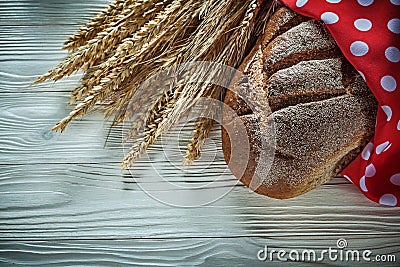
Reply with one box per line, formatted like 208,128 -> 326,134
36,0 -> 274,168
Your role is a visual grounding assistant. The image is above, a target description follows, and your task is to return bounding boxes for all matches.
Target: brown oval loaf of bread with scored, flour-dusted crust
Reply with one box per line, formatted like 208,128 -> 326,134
222,7 -> 377,199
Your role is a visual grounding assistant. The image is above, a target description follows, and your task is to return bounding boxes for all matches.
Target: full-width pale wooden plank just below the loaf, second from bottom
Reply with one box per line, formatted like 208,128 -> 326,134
0,163 -> 400,240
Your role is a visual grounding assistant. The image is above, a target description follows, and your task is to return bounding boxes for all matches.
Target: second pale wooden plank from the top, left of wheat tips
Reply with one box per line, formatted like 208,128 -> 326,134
0,25 -> 90,92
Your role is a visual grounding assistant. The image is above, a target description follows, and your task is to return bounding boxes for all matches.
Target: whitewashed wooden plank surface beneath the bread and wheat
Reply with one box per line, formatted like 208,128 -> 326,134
0,0 -> 400,266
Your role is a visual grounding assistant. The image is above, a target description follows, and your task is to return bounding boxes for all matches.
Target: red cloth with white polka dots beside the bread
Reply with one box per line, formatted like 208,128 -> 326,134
280,0 -> 400,206
